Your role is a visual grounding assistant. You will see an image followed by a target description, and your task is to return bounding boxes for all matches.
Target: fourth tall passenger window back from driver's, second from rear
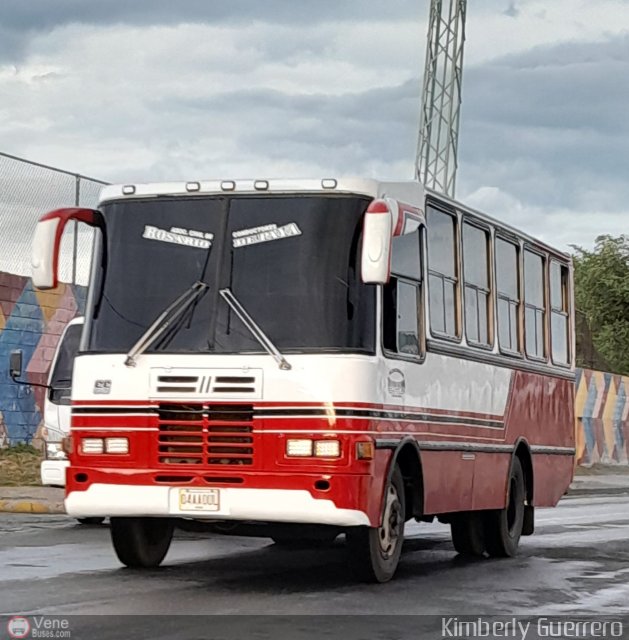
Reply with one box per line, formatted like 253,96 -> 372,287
524,249 -> 546,360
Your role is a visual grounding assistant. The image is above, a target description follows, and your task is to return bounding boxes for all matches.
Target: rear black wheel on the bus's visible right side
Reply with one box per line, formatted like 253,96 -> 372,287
485,457 -> 526,558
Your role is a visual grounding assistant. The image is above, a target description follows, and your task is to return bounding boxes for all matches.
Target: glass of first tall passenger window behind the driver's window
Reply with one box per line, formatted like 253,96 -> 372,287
426,207 -> 460,338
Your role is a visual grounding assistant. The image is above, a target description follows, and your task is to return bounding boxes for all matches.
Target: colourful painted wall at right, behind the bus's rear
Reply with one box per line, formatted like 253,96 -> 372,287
575,369 -> 629,466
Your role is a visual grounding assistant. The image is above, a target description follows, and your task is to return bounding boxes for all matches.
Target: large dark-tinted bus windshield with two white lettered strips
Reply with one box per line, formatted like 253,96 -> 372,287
88,195 -> 375,353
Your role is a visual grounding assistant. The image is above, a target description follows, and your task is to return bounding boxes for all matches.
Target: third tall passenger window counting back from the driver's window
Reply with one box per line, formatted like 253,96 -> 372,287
496,238 -> 522,353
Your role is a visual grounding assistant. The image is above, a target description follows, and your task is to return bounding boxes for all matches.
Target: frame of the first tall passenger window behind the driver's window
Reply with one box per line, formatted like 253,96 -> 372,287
424,205 -> 463,344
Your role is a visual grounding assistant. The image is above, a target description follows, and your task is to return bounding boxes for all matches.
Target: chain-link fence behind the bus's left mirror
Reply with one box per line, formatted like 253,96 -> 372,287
0,152 -> 107,285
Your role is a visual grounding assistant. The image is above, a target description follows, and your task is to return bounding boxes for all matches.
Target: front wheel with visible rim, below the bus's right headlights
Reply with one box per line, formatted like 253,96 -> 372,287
346,466 -> 406,582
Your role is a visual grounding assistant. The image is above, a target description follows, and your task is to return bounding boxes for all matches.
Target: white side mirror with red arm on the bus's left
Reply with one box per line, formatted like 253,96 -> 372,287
31,207 -> 102,289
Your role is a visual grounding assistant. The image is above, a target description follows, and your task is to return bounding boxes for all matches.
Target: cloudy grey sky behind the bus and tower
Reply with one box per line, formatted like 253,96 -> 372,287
0,0 -> 629,255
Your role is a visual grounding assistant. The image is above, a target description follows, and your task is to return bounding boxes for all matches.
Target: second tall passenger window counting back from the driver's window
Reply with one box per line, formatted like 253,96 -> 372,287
463,223 -> 491,346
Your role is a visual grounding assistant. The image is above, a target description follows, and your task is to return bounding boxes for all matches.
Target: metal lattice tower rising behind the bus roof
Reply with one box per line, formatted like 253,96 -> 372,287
416,0 -> 467,197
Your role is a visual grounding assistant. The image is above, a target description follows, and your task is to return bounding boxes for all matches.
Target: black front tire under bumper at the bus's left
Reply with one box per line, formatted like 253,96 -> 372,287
111,518 -> 175,567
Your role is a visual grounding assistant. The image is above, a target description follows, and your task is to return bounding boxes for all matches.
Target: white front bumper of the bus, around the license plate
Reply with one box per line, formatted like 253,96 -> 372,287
65,483 -> 369,527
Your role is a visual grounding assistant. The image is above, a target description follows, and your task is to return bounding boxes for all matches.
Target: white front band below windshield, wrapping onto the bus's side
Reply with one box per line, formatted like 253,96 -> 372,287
72,353 -> 512,418
